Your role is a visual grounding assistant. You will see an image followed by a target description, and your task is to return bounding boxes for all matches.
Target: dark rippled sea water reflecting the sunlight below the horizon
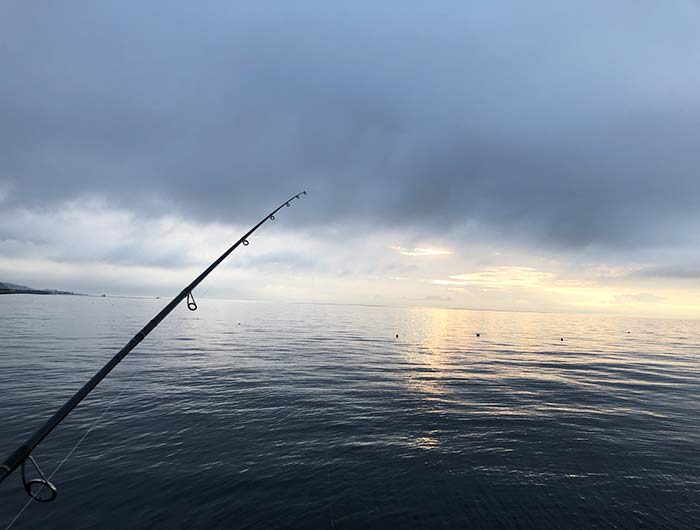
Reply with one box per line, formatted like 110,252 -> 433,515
0,295 -> 700,529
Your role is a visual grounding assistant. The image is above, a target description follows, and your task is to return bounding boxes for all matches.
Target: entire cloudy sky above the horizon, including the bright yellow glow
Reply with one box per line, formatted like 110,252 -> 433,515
0,0 -> 700,317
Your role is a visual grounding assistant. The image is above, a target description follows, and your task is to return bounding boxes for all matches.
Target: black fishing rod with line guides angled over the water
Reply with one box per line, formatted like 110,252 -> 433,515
0,191 -> 306,502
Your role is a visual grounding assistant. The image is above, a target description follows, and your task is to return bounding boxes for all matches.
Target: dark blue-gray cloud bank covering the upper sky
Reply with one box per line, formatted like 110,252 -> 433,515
0,0 -> 700,252
